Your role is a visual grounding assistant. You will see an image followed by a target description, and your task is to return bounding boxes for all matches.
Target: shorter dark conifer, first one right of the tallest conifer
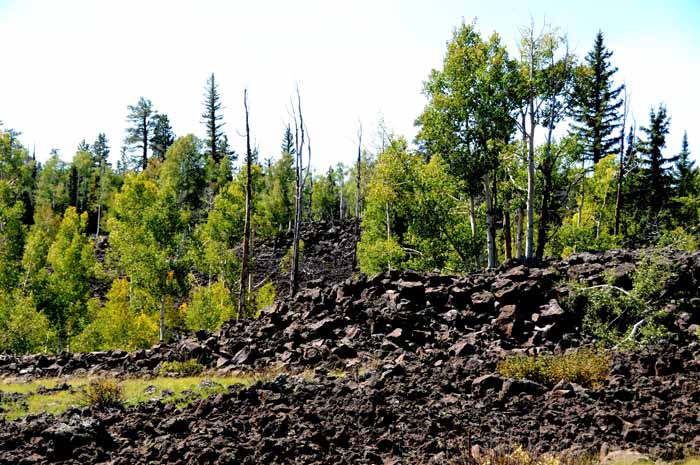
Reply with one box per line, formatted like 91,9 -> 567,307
639,105 -> 678,212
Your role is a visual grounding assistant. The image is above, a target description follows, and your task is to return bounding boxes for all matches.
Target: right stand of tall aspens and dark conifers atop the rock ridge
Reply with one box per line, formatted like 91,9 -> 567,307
358,23 -> 700,272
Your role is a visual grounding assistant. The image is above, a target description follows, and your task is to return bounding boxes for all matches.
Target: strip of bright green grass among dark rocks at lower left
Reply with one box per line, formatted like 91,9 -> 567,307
0,372 -> 268,420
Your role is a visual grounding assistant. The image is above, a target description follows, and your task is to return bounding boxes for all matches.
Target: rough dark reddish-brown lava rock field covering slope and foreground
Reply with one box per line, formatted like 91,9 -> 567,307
0,245 -> 700,464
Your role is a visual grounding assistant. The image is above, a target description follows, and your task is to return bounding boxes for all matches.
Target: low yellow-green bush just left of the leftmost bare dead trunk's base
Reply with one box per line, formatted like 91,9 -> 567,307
185,281 -> 237,331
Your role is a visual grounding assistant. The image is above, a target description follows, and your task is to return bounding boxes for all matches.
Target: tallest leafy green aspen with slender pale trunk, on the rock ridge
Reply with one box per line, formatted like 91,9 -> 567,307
418,23 -> 518,267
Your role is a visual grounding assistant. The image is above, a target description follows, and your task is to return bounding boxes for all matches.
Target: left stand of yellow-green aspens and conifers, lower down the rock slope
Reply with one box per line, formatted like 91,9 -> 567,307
0,75 -> 356,353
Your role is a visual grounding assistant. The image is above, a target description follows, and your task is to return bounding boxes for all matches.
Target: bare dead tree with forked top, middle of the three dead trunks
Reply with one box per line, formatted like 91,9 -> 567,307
289,87 -> 311,295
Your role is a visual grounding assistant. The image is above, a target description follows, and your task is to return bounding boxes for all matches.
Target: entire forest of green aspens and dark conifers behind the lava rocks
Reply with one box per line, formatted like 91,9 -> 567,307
0,22 -> 700,354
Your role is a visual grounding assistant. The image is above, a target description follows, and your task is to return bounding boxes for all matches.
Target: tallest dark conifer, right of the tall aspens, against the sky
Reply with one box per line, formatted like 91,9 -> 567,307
573,31 -> 624,163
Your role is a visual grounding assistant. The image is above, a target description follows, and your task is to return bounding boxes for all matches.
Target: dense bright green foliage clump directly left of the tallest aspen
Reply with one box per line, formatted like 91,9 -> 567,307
357,138 -> 473,273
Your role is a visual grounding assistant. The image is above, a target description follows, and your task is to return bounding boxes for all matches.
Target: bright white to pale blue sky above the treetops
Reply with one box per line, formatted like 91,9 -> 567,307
0,0 -> 700,171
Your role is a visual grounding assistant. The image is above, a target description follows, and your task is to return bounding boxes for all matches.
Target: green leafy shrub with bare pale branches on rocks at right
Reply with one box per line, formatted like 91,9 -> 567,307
569,255 -> 675,348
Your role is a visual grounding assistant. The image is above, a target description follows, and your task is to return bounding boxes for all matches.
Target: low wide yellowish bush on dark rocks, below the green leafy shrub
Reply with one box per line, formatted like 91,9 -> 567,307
498,349 -> 610,387
